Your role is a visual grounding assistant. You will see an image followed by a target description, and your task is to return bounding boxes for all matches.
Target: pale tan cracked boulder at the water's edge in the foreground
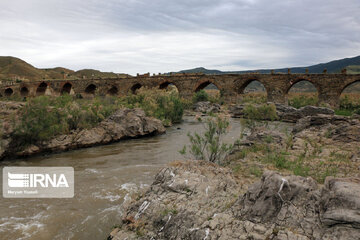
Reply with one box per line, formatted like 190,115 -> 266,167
110,161 -> 240,239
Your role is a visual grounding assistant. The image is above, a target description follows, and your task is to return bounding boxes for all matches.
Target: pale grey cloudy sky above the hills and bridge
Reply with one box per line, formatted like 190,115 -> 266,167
0,0 -> 360,74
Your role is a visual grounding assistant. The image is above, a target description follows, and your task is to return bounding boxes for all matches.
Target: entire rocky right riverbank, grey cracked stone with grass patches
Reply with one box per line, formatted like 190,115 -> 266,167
108,110 -> 360,240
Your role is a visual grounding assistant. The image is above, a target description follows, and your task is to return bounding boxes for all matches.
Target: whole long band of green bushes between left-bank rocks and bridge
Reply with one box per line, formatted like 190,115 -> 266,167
12,89 -> 184,146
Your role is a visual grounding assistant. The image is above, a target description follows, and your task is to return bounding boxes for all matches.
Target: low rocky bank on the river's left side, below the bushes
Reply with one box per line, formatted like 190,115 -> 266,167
0,108 -> 166,159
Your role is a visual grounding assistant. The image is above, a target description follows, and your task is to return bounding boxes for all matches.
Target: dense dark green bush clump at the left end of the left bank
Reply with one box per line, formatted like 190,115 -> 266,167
13,95 -> 120,145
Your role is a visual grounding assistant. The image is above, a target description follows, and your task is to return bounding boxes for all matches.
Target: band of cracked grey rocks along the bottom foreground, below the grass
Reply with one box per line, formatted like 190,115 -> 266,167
109,161 -> 360,240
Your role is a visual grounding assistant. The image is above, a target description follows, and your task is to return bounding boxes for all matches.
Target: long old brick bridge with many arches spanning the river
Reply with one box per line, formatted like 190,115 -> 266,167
0,73 -> 360,106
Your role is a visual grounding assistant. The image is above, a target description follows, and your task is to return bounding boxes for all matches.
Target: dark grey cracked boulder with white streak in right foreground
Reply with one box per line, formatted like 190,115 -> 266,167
235,171 -> 320,237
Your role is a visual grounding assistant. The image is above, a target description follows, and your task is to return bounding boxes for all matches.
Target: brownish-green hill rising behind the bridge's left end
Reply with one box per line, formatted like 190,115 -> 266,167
0,56 -> 129,81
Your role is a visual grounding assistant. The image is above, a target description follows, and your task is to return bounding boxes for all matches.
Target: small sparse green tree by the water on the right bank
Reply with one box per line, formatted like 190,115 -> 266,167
180,116 -> 233,164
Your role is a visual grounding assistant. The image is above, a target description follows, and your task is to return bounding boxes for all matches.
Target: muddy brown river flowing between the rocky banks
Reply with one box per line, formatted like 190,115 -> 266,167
0,117 -> 248,240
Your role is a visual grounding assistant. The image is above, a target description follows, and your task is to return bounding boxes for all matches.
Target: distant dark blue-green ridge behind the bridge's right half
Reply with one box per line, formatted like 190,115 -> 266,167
179,56 -> 360,74
